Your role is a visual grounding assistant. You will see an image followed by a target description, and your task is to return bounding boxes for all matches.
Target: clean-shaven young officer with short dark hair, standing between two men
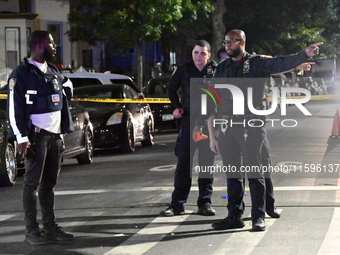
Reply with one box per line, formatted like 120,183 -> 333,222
160,40 -> 216,216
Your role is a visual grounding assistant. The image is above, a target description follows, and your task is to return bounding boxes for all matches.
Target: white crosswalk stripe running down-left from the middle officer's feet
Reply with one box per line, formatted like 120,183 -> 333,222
105,211 -> 192,255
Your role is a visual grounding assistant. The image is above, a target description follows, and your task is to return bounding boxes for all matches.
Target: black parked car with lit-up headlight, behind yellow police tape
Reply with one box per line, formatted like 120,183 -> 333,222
73,84 -> 154,153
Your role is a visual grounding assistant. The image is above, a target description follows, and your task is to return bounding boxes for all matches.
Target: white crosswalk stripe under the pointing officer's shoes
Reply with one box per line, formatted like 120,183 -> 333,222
213,210 -> 282,255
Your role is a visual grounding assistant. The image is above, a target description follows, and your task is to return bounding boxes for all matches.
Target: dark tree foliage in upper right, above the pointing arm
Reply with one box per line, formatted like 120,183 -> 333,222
224,0 -> 340,57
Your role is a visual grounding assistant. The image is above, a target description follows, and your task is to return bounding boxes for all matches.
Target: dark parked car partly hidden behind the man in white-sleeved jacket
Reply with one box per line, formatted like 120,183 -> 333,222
0,91 -> 94,187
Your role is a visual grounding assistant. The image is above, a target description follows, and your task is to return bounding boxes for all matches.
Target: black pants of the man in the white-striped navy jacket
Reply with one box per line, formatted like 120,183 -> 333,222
23,130 -> 63,232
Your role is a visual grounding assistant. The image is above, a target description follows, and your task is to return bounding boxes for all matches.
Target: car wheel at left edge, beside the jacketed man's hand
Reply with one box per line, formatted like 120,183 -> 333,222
0,143 -> 18,187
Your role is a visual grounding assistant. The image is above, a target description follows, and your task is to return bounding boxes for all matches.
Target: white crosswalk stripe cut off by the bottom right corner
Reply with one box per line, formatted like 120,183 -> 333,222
318,208 -> 340,255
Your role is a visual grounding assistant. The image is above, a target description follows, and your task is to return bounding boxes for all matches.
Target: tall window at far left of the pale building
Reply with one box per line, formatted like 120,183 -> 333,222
6,28 -> 20,69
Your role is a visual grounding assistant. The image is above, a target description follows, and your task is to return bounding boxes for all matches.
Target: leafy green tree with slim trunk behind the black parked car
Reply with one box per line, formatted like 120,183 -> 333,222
68,0 -> 213,90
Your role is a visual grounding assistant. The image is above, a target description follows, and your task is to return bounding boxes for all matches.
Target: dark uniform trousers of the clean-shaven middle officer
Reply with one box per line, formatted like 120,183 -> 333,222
171,126 -> 215,207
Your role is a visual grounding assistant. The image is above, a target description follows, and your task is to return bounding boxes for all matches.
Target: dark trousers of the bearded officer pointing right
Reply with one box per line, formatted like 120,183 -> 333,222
219,127 -> 266,220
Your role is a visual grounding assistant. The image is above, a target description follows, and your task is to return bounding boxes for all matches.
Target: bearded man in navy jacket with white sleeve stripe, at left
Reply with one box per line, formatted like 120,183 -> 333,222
7,31 -> 74,245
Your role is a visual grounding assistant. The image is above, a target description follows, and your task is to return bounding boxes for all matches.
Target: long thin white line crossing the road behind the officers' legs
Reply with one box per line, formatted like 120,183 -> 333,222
54,186 -> 340,196
